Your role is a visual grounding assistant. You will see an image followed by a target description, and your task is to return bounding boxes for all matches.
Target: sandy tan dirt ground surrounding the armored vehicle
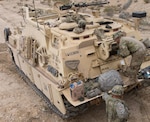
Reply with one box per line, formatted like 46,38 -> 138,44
0,0 -> 150,122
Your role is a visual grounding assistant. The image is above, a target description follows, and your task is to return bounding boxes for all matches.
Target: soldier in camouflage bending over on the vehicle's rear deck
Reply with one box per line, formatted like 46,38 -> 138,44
113,31 -> 146,84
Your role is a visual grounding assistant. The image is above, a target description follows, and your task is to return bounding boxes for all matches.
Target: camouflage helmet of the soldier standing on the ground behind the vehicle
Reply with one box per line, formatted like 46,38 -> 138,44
111,85 -> 124,96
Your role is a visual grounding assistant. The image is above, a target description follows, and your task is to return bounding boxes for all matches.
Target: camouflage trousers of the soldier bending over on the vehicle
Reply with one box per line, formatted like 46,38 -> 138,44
126,49 -> 145,79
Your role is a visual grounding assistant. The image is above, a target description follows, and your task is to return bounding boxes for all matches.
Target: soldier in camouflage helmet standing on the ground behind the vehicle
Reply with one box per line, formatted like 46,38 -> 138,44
102,85 -> 129,122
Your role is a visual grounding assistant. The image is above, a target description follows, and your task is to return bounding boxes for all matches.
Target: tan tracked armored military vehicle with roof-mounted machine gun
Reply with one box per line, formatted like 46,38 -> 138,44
4,1 -> 150,118
